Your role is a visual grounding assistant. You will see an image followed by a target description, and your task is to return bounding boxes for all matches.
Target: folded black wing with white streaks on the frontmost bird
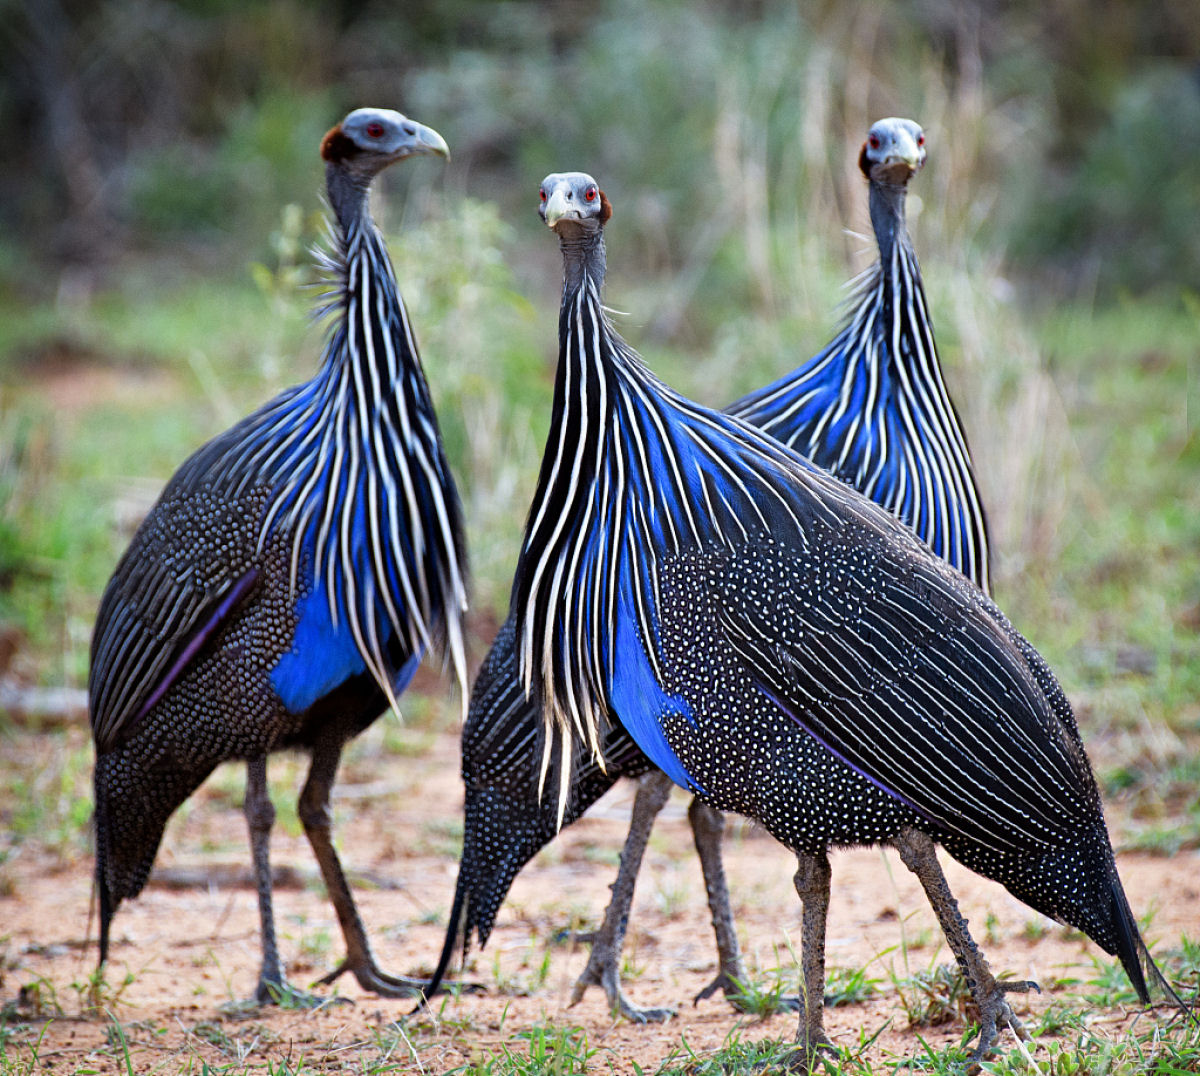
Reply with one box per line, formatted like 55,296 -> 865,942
719,525 -> 1094,850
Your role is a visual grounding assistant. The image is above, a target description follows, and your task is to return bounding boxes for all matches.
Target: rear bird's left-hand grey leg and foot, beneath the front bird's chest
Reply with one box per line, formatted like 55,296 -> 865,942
571,770 -> 674,1023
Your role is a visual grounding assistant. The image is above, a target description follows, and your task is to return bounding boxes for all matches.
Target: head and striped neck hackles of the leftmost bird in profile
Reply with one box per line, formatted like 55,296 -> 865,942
251,109 -> 467,709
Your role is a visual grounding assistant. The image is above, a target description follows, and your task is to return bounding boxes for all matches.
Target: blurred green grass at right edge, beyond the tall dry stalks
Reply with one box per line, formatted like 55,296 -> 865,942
1002,302 -> 1200,743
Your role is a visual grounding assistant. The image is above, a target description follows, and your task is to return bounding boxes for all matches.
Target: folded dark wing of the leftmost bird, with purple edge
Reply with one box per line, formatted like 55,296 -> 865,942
88,487 -> 262,753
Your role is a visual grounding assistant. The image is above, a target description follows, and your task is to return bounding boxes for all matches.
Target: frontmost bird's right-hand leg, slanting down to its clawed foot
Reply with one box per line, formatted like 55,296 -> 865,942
892,829 -> 1040,1065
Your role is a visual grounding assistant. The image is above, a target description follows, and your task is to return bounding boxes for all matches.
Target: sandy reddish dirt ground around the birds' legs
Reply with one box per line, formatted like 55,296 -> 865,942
0,719 -> 1200,1074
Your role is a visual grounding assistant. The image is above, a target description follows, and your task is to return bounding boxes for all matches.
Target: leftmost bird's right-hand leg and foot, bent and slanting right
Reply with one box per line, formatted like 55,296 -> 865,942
299,735 -> 428,998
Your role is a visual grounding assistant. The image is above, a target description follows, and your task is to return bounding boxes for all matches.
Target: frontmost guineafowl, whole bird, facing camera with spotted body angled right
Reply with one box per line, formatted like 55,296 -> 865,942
512,173 -> 1182,1068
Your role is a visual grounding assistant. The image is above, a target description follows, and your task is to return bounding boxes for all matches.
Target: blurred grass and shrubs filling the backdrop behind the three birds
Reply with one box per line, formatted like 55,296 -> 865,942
0,0 -> 1200,840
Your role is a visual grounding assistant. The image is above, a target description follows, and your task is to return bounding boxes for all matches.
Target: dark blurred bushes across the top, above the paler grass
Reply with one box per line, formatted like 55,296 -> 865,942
7,0 -> 1200,293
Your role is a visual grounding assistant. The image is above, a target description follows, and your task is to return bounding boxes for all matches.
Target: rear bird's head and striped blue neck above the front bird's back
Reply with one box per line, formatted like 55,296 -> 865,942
728,118 -> 990,590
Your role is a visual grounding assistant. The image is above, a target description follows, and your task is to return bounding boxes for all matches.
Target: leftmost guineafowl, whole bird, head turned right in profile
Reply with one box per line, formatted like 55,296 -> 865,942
89,108 -> 466,1002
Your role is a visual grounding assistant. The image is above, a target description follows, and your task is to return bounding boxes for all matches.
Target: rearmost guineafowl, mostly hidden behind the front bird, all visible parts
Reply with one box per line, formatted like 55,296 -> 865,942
422,118 -> 989,1020
